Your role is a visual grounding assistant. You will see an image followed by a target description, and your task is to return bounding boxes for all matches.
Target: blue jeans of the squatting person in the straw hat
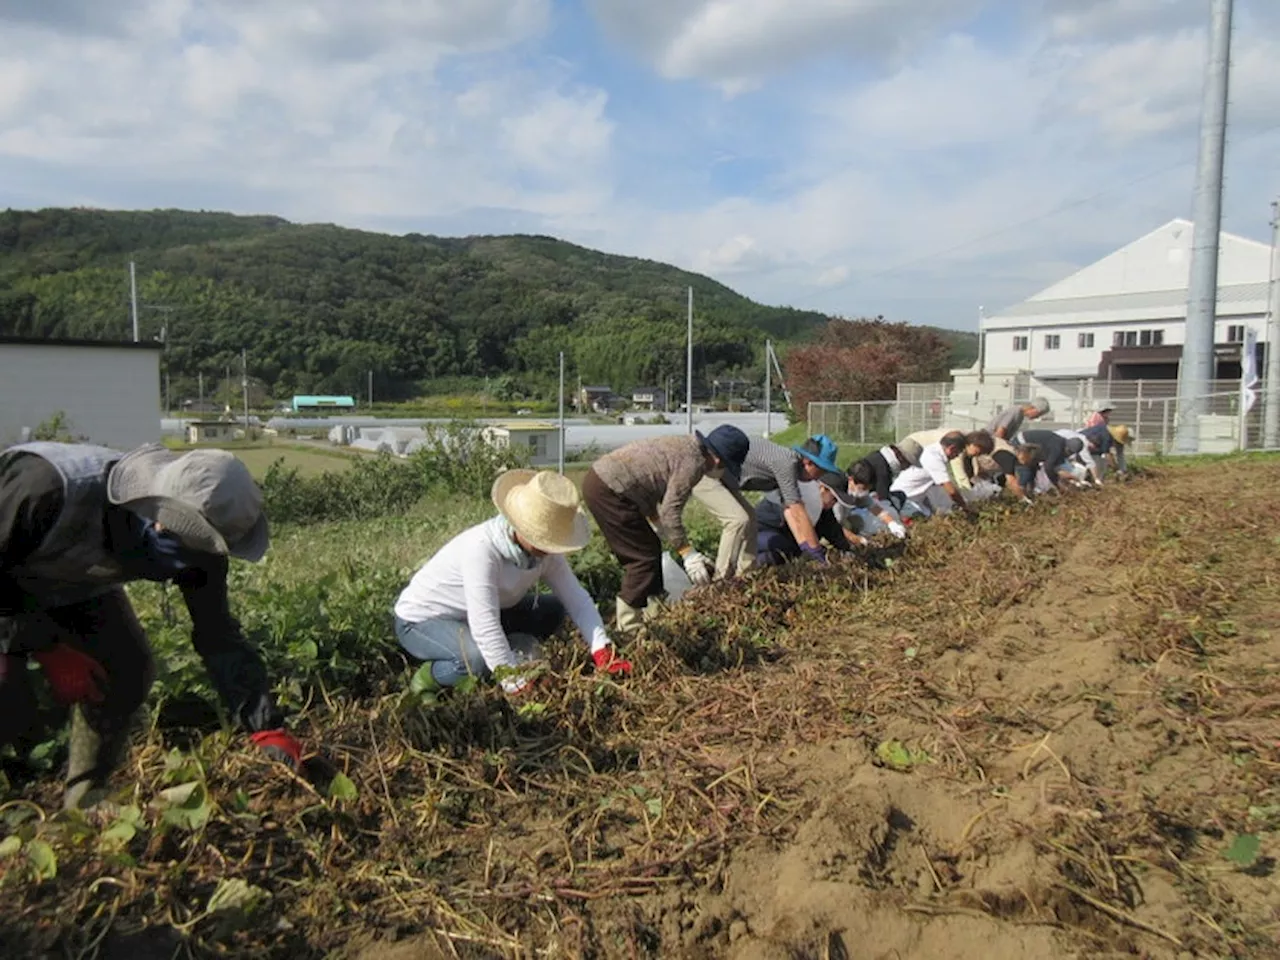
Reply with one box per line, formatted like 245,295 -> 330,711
396,594 -> 564,686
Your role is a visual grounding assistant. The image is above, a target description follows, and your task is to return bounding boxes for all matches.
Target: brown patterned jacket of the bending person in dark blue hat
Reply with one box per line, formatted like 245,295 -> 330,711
591,436 -> 707,550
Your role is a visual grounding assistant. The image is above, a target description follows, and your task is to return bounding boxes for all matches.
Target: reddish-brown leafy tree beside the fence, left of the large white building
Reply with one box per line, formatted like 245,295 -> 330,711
786,317 -> 950,417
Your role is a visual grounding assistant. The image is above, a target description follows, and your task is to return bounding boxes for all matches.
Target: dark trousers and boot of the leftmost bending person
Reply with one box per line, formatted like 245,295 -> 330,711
0,589 -> 155,795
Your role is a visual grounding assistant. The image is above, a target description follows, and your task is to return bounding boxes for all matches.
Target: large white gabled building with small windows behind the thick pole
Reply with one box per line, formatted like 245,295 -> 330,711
977,220 -> 1271,388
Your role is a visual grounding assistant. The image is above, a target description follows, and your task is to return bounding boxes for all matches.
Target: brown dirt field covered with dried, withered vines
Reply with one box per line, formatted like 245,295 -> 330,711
0,460 -> 1280,960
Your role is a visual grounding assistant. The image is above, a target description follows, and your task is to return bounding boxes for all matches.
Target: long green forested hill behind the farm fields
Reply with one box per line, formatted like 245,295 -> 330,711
0,209 -> 963,397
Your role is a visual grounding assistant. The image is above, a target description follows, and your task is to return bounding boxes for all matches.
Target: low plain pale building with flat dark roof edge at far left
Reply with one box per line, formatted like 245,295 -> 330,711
0,337 -> 161,449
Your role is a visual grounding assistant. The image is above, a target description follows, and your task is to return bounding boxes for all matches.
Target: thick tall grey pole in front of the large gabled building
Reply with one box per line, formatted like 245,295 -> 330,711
1174,0 -> 1231,453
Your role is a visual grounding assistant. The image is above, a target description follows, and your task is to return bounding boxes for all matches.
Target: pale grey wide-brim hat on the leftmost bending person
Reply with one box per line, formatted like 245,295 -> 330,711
106,443 -> 271,563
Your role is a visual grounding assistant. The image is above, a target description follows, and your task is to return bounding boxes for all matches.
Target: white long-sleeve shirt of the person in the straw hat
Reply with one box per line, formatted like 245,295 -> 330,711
396,517 -> 609,669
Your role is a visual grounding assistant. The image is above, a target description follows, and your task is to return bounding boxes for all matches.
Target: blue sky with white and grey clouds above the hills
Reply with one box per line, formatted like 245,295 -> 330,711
0,0 -> 1280,328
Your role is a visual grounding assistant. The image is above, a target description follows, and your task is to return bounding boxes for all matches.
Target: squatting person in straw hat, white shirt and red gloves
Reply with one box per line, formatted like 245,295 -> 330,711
396,470 -> 631,694
